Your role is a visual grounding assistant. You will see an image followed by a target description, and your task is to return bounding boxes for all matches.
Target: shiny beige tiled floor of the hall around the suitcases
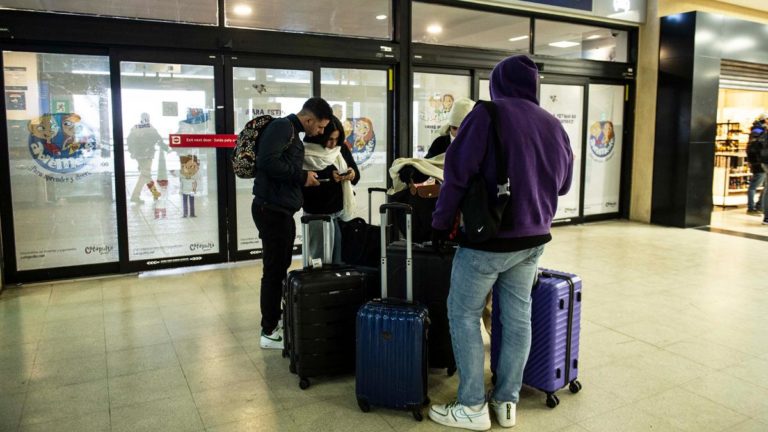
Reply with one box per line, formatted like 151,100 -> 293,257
0,218 -> 768,432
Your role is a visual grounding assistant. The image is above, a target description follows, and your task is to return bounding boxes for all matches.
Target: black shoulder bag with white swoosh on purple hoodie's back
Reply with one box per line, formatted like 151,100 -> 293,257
461,101 -> 510,243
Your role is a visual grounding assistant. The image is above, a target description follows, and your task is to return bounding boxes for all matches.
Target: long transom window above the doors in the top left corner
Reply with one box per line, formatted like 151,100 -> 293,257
0,0 -> 218,25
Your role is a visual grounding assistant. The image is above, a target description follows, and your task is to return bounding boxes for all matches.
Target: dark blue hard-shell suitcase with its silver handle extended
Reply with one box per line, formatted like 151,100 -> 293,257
355,204 -> 429,421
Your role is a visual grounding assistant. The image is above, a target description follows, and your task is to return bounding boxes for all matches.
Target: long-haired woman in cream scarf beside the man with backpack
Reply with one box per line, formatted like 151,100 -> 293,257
302,116 -> 360,263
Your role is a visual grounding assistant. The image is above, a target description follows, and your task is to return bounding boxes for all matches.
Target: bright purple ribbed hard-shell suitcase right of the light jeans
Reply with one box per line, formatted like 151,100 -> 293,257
491,269 -> 581,408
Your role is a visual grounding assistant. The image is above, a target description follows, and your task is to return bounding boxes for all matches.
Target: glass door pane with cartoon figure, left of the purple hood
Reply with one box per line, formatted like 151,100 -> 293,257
413,72 -> 471,157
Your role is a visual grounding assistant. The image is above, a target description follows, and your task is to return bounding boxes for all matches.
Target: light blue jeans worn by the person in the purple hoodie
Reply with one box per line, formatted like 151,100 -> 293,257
448,246 -> 544,406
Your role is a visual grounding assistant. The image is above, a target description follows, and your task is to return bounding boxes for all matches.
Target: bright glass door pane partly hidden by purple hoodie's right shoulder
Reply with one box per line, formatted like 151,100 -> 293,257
539,84 -> 584,220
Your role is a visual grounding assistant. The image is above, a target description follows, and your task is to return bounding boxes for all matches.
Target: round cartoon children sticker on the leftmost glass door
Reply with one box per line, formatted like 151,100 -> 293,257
27,113 -> 97,178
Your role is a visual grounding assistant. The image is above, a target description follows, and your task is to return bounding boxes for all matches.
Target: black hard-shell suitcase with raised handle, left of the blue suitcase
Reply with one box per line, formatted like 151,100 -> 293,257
283,216 -> 372,389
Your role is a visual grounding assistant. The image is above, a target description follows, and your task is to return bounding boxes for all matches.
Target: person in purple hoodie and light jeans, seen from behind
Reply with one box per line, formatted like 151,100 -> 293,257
429,56 -> 573,430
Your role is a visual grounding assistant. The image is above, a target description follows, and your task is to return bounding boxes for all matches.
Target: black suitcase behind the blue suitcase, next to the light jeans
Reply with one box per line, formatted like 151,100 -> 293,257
387,241 -> 456,376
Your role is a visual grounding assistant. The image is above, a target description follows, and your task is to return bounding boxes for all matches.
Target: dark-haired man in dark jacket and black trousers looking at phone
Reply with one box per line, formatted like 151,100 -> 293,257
251,98 -> 333,349
